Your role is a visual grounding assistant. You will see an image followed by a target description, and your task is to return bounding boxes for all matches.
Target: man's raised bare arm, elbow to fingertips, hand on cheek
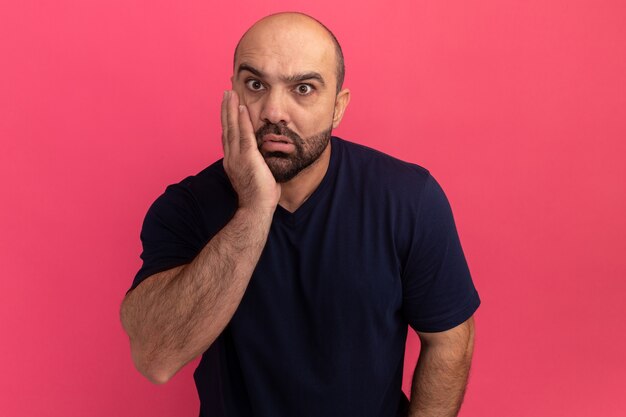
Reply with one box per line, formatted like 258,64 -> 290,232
120,92 -> 280,383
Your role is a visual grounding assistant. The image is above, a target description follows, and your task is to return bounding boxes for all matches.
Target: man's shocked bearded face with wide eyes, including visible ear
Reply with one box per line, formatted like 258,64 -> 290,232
233,17 -> 349,182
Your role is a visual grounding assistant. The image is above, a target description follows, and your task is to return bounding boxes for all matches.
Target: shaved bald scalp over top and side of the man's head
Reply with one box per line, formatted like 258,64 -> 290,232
234,12 -> 345,92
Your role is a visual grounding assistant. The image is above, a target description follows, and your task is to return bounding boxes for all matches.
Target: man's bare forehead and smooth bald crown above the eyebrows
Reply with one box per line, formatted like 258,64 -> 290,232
235,19 -> 336,82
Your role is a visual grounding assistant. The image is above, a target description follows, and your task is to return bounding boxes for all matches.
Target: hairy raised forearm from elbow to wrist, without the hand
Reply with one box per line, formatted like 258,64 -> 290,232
121,209 -> 273,383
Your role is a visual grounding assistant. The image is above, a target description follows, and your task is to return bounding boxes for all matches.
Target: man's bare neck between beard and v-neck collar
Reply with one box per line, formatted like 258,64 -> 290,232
278,141 -> 330,213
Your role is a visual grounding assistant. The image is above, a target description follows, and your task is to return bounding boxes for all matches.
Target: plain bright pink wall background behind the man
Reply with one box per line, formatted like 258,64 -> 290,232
0,0 -> 626,417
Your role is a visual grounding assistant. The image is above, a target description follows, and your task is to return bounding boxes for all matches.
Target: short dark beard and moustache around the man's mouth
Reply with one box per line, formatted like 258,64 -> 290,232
254,123 -> 332,183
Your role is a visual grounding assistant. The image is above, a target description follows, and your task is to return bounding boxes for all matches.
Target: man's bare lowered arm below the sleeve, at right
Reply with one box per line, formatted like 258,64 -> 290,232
409,317 -> 474,417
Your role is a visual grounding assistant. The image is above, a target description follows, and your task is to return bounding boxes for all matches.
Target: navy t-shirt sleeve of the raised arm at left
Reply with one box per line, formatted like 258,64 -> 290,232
131,184 -> 206,289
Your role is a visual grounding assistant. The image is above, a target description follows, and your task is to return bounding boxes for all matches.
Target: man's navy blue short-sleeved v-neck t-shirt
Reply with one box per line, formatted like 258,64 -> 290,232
133,137 -> 480,417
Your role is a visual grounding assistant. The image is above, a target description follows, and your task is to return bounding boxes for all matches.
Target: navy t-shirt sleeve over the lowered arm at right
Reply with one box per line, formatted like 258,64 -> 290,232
402,175 -> 480,332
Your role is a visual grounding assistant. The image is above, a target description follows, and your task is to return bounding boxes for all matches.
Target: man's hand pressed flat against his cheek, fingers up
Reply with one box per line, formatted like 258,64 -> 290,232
222,91 -> 281,212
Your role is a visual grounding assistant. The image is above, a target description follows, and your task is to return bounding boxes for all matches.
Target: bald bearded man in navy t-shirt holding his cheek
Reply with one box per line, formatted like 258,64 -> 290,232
121,13 -> 480,416
